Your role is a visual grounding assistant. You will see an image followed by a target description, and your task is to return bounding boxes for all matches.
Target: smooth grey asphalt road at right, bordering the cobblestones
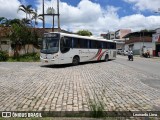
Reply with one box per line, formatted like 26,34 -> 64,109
115,56 -> 160,89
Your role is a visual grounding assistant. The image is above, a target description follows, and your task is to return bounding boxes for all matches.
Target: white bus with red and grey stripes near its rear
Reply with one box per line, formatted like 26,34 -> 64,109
40,32 -> 116,65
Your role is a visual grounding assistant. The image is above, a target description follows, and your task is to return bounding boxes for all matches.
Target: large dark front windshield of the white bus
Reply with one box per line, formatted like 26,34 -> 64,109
41,37 -> 59,54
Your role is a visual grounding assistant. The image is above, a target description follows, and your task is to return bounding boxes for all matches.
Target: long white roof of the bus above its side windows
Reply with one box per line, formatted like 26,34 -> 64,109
45,32 -> 116,43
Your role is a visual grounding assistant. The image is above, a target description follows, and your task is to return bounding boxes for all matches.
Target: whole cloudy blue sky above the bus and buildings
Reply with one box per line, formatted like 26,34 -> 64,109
0,0 -> 160,35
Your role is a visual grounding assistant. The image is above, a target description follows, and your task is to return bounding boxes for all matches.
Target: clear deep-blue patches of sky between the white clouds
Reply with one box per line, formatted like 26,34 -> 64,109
23,0 -> 159,17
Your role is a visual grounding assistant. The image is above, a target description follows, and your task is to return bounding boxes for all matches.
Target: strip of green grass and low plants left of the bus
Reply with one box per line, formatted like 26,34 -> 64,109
7,53 -> 40,62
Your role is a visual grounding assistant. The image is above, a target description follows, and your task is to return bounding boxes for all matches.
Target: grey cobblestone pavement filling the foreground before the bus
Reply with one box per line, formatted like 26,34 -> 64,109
0,61 -> 160,111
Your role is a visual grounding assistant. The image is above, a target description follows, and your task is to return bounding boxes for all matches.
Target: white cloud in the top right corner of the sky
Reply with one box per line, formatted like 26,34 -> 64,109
124,0 -> 160,12
